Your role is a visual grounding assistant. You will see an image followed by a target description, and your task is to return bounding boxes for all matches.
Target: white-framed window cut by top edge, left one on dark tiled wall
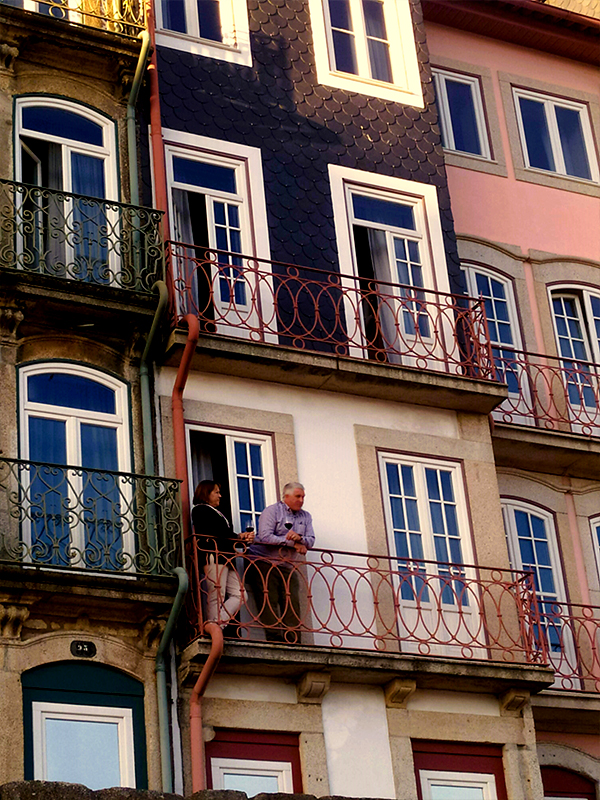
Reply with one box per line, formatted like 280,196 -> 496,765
156,0 -> 252,67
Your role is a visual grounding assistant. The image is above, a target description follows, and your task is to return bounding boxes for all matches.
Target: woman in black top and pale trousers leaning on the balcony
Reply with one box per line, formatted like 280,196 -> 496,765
192,481 -> 254,628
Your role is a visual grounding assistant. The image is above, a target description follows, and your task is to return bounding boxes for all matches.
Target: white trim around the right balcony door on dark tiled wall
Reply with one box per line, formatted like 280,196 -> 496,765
329,164 -> 450,292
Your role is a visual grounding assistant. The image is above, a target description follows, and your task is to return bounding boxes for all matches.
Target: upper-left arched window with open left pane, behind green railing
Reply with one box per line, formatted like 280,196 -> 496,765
15,96 -> 118,283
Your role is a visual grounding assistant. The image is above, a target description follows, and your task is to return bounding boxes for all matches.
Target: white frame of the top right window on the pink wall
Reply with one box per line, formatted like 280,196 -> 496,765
512,86 -> 600,183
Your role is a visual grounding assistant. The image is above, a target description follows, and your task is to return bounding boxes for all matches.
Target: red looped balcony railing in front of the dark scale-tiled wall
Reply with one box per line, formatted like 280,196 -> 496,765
170,242 -> 496,380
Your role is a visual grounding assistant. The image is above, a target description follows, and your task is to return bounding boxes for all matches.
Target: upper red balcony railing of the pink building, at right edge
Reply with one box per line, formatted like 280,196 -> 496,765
493,348 -> 600,436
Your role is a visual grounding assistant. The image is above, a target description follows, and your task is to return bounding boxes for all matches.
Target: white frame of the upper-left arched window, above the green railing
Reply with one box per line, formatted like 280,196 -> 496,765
14,95 -> 119,201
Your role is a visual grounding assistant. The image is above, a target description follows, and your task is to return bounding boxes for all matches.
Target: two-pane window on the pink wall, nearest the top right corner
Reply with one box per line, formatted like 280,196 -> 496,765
513,88 -> 599,182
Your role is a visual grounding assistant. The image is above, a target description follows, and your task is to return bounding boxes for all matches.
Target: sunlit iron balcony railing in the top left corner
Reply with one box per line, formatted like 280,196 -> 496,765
0,0 -> 146,36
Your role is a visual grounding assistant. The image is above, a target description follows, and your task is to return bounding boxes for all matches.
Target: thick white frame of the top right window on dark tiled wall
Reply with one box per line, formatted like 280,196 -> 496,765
309,0 -> 425,108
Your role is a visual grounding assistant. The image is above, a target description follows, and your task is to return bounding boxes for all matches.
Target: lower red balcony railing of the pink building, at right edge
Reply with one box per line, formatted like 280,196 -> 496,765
538,602 -> 600,692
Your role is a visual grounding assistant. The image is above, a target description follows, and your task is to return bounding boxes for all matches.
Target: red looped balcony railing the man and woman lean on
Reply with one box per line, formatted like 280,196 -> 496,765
187,536 -> 548,664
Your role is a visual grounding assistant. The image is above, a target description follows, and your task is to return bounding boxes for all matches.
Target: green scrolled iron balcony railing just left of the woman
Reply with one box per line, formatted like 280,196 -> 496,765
0,458 -> 182,576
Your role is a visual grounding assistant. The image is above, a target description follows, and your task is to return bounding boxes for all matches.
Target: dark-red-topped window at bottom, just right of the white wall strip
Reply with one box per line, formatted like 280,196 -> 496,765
412,740 -> 507,800
